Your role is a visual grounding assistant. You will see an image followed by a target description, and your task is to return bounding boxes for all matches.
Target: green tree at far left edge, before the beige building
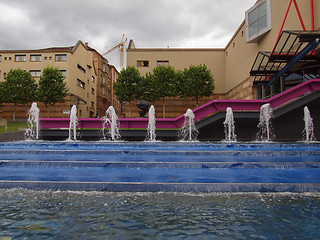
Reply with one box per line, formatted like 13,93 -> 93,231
1,69 -> 38,121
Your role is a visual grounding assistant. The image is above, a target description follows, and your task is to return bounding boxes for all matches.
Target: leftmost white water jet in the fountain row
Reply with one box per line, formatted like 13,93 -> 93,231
25,102 -> 40,140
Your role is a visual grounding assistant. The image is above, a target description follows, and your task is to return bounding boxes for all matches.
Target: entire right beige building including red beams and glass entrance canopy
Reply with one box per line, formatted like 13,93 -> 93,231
127,0 -> 320,117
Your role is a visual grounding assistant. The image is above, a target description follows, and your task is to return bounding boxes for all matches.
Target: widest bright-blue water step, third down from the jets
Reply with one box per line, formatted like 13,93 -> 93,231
0,167 -> 320,183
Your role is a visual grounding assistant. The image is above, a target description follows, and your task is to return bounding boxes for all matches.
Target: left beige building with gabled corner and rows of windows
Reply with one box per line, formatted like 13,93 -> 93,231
0,41 -> 120,119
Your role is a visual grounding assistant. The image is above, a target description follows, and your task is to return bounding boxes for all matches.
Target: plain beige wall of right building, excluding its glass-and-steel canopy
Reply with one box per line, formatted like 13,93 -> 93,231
127,0 -> 320,105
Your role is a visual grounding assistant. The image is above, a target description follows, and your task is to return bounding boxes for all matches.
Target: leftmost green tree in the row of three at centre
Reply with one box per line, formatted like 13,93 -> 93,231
113,66 -> 144,117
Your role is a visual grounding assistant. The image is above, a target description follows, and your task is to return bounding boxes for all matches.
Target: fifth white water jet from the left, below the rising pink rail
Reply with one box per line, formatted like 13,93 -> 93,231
180,109 -> 199,141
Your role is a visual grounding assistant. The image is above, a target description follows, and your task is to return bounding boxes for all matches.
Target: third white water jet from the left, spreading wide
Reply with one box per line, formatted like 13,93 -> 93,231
102,106 -> 121,141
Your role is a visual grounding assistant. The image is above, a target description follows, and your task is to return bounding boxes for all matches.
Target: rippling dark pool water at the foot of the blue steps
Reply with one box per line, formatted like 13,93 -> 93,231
0,189 -> 320,240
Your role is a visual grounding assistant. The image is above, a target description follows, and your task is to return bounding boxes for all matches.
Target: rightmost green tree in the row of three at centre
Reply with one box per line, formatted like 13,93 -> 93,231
178,65 -> 214,106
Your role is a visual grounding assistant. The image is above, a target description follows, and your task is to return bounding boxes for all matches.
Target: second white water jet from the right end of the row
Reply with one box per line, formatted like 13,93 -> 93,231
258,103 -> 273,141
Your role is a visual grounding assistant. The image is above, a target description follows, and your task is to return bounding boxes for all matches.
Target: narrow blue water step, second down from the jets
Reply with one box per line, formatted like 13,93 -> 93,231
0,149 -> 320,163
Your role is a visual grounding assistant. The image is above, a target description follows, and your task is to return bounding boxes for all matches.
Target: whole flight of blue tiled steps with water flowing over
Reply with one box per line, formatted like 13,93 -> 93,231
0,141 -> 320,192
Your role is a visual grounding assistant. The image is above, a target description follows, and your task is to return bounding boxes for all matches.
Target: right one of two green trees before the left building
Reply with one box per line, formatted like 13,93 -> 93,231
38,67 -> 68,117
